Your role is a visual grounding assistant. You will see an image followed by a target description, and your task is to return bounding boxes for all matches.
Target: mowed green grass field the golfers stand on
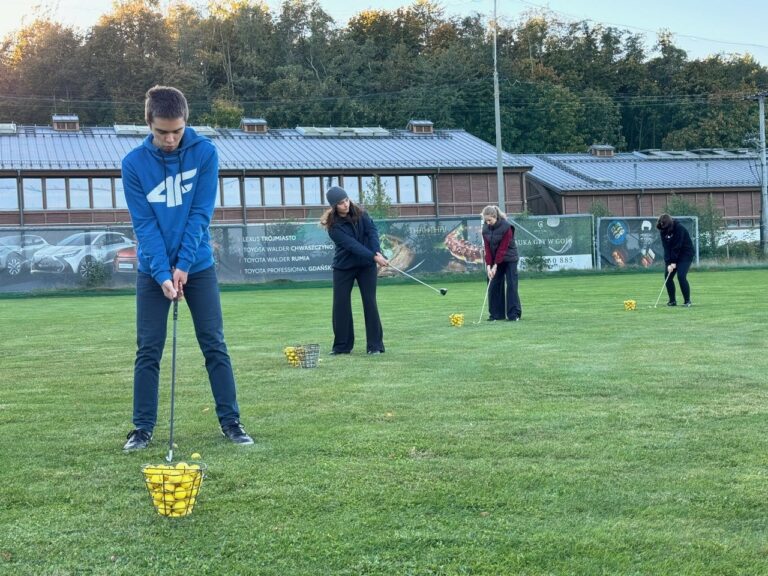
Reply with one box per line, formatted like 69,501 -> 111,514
0,270 -> 768,575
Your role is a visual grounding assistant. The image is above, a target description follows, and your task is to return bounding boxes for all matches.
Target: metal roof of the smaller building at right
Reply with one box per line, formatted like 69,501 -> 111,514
517,149 -> 760,192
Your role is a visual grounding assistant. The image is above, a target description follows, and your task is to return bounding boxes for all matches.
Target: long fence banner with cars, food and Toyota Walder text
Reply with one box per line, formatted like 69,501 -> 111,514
0,216 -> 593,292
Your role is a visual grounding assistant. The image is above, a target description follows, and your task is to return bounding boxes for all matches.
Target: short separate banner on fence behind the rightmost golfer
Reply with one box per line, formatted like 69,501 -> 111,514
596,216 -> 699,268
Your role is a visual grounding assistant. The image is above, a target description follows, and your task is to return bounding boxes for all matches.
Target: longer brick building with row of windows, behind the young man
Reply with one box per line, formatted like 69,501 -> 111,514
0,115 -> 528,227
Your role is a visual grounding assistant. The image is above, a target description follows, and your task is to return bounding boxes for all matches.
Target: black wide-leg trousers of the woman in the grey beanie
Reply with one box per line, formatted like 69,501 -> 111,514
333,265 -> 384,352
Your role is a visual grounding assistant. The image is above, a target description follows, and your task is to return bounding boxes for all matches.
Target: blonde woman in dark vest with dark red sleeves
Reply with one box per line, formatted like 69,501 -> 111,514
481,206 -> 523,322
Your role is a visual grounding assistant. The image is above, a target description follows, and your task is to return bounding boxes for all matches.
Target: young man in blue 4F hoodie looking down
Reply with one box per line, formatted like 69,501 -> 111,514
122,86 -> 253,451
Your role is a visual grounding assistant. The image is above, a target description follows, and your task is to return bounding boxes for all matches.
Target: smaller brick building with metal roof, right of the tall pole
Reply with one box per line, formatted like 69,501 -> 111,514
515,145 -> 761,229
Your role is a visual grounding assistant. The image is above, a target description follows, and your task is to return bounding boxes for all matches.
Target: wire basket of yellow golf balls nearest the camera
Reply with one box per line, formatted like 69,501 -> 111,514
141,462 -> 206,518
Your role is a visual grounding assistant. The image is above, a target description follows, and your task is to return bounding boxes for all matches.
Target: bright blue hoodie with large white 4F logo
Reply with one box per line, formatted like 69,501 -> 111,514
123,127 -> 219,284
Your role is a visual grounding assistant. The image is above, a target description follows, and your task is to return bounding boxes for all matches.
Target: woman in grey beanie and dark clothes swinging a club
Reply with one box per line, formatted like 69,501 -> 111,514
320,186 -> 389,354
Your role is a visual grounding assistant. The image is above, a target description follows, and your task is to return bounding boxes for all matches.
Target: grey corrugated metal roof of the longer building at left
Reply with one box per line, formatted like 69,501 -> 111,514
0,126 -> 525,171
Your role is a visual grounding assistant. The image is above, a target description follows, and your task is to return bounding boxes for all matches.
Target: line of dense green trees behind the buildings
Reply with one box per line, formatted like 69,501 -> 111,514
0,0 -> 768,153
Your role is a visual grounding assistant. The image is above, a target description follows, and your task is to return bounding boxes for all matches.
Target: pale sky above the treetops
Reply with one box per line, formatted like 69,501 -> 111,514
0,0 -> 768,66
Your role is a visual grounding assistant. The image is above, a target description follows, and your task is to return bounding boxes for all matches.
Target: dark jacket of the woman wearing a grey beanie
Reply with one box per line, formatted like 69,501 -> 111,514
328,212 -> 381,270
